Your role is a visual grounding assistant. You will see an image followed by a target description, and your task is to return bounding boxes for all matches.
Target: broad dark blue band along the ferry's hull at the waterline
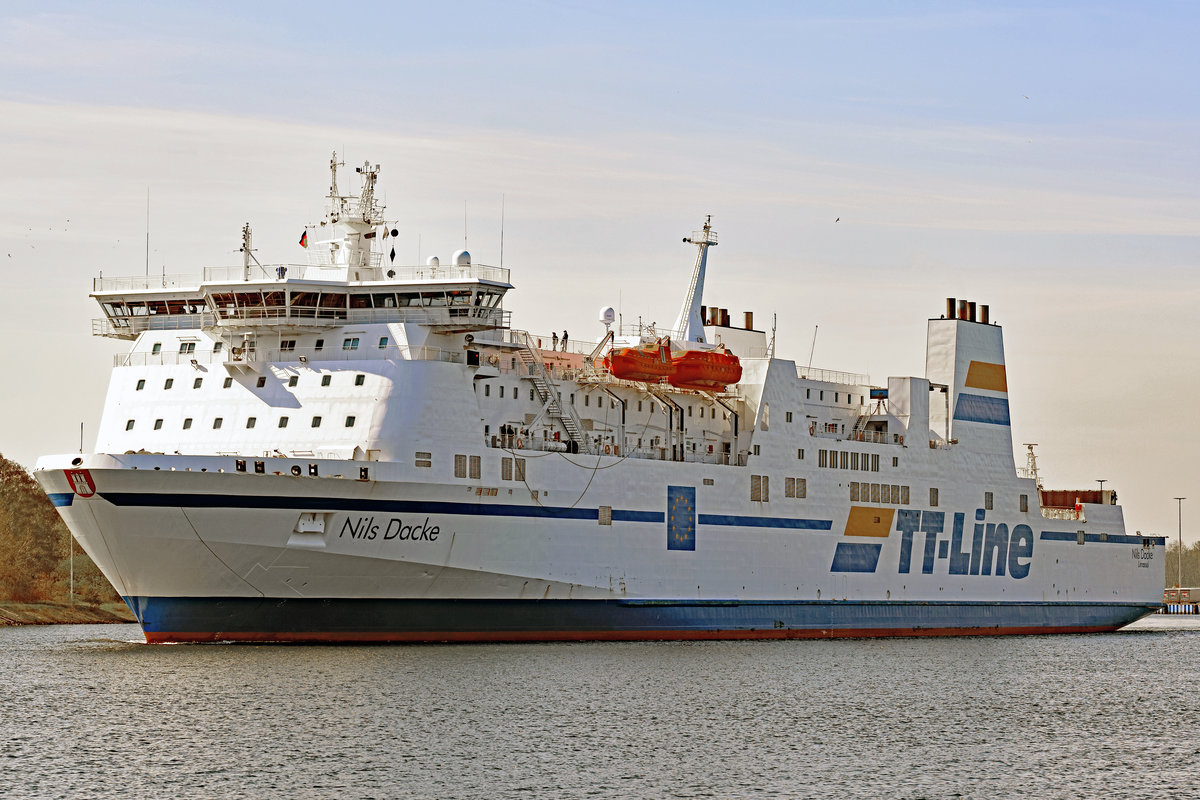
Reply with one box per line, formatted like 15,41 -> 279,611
125,596 -> 1159,640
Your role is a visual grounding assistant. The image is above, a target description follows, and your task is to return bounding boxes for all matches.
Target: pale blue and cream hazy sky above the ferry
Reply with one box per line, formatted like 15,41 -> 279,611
0,0 -> 1200,542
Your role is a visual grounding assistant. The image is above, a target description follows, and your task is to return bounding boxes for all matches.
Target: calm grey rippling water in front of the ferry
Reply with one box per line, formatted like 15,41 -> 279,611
0,616 -> 1200,798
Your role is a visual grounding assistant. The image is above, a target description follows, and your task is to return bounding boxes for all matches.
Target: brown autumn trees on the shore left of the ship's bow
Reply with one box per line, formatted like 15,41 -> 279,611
0,456 -> 120,606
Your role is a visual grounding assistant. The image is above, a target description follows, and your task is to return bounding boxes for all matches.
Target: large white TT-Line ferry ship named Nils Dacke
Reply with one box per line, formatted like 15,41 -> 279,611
36,154 -> 1164,642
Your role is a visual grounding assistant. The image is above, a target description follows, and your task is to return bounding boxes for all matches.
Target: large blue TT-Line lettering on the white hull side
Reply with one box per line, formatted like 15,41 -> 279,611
896,509 -> 1033,578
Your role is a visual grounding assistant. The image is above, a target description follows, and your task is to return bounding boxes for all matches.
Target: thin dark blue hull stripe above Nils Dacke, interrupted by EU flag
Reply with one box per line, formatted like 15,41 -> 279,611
98,492 -> 833,530
